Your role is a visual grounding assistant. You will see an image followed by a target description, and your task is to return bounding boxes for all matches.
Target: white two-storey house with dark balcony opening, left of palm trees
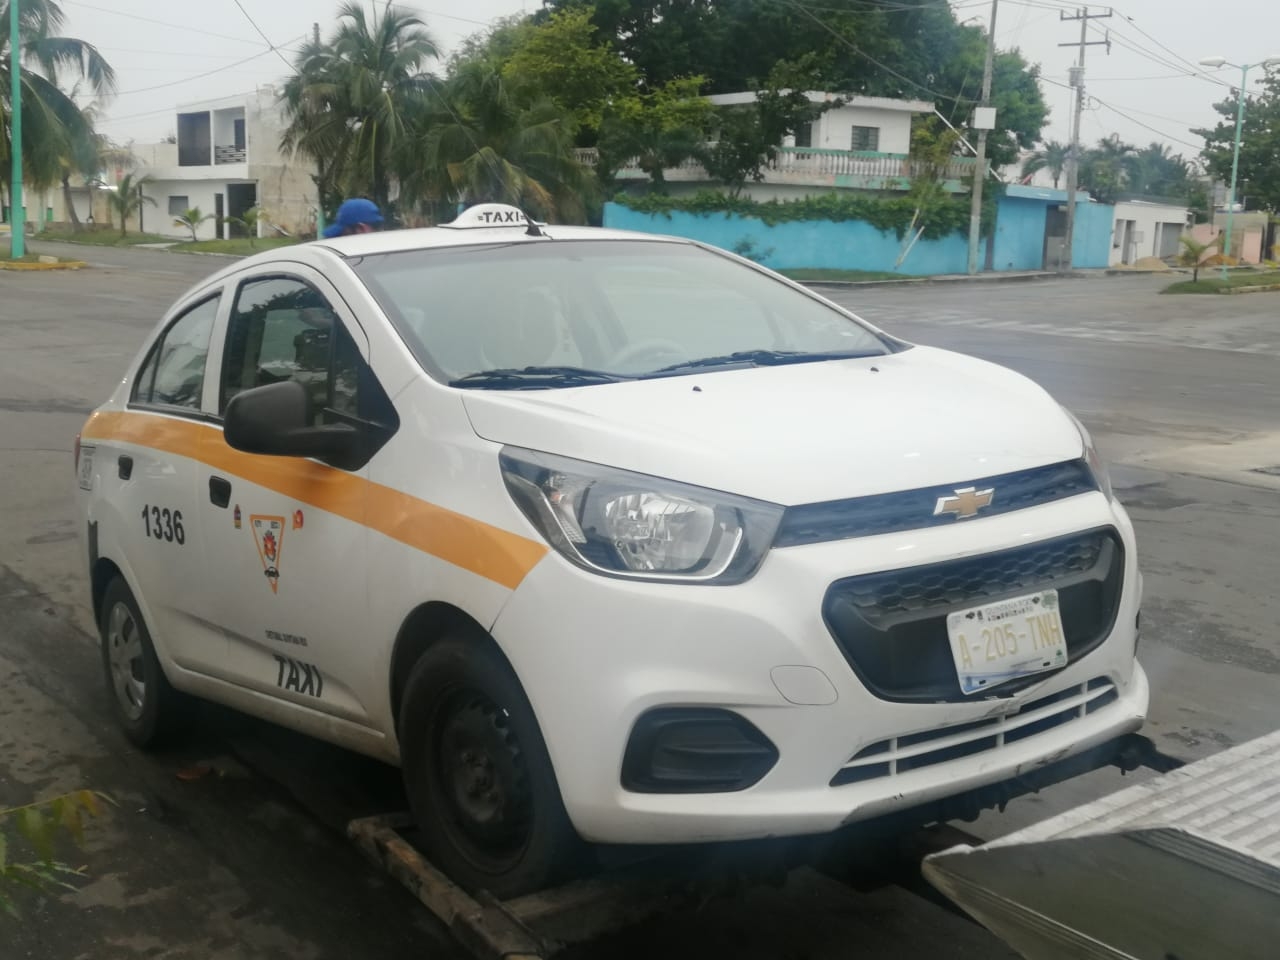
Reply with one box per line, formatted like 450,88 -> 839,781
133,86 -> 316,239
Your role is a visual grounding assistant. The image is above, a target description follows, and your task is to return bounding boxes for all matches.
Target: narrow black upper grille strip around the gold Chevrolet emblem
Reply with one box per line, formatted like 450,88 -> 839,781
773,460 -> 1098,547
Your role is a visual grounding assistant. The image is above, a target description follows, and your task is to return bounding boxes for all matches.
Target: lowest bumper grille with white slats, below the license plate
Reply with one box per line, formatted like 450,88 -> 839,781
831,677 -> 1120,787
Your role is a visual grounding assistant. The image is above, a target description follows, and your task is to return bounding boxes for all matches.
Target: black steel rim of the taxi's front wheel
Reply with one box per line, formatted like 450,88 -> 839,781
435,691 -> 534,869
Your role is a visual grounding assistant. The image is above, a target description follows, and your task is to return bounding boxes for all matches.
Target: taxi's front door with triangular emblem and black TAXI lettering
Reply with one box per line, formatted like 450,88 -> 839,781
192,268 -> 386,723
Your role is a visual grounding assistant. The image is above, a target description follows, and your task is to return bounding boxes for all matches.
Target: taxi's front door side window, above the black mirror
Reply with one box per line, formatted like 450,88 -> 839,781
219,276 -> 394,425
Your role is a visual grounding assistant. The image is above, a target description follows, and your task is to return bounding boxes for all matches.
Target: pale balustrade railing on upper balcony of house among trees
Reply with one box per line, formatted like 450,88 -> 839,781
576,147 -> 977,189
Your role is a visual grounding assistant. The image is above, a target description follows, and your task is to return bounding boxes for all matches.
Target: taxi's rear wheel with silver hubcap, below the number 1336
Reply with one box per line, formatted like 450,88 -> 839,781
97,577 -> 193,749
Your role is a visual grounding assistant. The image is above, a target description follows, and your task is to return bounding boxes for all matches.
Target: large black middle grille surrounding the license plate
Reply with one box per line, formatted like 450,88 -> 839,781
822,527 -> 1124,701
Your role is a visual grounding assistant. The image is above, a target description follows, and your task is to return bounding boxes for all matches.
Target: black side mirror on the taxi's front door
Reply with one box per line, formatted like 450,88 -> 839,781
223,380 -> 361,466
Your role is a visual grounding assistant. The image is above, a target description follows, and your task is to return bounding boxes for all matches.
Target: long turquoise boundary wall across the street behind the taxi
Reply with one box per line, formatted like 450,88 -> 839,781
604,195 -> 1115,276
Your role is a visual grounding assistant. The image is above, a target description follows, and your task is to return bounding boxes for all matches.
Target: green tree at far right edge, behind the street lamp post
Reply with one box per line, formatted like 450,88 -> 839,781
1193,70 -> 1280,212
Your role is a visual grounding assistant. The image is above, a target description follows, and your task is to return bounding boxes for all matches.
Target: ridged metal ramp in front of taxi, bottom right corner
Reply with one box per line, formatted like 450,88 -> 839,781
923,731 -> 1280,960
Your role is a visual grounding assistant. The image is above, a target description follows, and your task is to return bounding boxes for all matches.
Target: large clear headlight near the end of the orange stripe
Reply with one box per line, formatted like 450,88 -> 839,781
499,447 -> 782,584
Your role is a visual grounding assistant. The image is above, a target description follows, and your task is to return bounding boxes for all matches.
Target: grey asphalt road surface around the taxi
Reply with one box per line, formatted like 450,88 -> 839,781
0,244 -> 1280,960
